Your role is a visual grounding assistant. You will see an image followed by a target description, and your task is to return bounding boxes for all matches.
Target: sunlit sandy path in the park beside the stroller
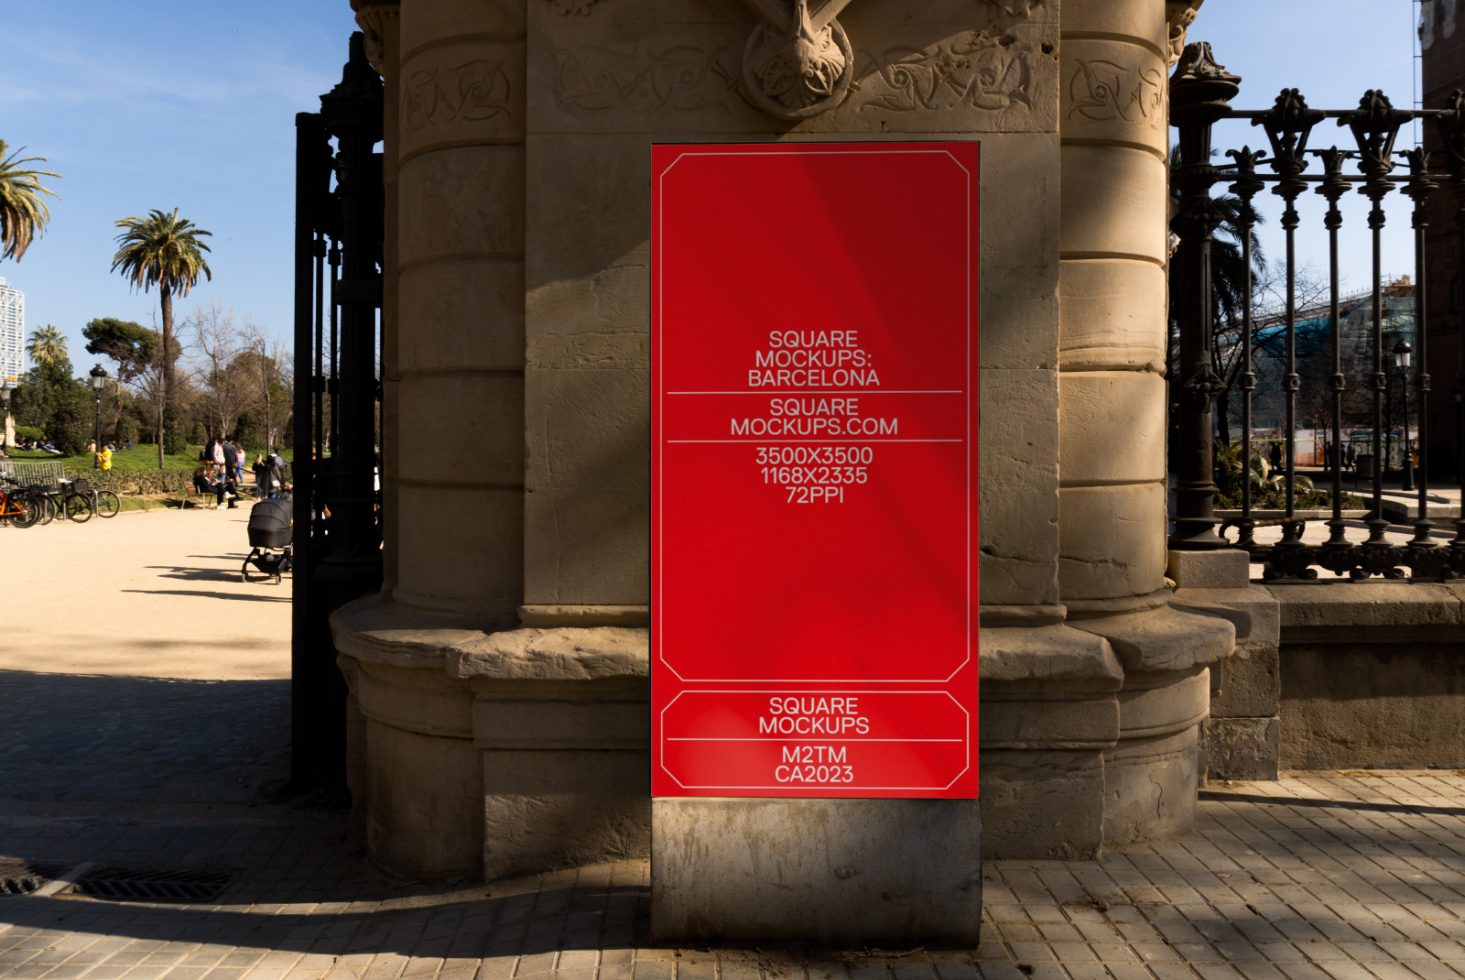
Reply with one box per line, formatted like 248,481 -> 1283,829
0,502 -> 290,680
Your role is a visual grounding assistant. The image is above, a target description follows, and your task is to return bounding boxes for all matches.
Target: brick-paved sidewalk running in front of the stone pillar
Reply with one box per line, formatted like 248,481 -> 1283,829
0,772 -> 1465,980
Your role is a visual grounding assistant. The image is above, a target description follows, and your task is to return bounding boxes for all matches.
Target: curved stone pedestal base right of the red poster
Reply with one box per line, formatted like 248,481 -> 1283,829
982,599 -> 1244,858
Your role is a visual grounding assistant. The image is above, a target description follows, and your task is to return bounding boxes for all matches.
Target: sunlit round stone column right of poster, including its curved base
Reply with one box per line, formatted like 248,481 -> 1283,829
1059,0 -> 1234,842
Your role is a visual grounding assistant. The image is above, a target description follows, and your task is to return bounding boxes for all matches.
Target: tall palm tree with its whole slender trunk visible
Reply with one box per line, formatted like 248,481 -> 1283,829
111,208 -> 214,470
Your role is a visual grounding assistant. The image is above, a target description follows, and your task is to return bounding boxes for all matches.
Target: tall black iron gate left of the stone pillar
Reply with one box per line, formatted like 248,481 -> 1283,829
290,34 -> 382,790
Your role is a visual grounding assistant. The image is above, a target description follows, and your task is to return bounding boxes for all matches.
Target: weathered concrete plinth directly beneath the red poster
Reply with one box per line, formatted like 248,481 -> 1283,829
650,798 -> 982,946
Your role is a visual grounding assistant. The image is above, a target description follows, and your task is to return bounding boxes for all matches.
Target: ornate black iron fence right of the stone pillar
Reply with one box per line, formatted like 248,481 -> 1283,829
1171,42 -> 1465,580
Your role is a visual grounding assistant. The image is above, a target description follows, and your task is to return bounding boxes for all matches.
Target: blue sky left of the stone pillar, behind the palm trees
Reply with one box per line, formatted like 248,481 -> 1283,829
0,0 -> 355,372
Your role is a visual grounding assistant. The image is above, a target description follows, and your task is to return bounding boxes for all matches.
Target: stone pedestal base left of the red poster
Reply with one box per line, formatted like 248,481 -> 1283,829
333,596 -> 650,880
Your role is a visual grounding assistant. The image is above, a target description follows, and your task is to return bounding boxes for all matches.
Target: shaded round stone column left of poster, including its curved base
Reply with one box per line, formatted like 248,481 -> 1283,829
334,0 -> 524,875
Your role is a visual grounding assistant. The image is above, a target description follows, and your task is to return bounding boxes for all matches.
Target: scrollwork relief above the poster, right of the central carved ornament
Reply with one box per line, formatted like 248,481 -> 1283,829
857,32 -> 1036,113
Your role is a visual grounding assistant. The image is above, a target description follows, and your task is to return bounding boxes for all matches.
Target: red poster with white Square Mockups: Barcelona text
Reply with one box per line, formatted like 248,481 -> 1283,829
650,142 -> 977,798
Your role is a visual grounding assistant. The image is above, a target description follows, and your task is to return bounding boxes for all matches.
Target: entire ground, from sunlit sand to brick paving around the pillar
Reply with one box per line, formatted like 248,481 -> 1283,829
0,511 -> 1465,980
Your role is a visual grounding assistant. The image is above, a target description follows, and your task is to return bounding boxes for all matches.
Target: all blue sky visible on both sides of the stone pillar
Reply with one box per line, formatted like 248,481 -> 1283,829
0,0 -> 1414,371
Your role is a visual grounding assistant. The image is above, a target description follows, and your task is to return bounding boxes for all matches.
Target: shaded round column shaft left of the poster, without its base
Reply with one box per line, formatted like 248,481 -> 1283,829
393,0 -> 524,626
